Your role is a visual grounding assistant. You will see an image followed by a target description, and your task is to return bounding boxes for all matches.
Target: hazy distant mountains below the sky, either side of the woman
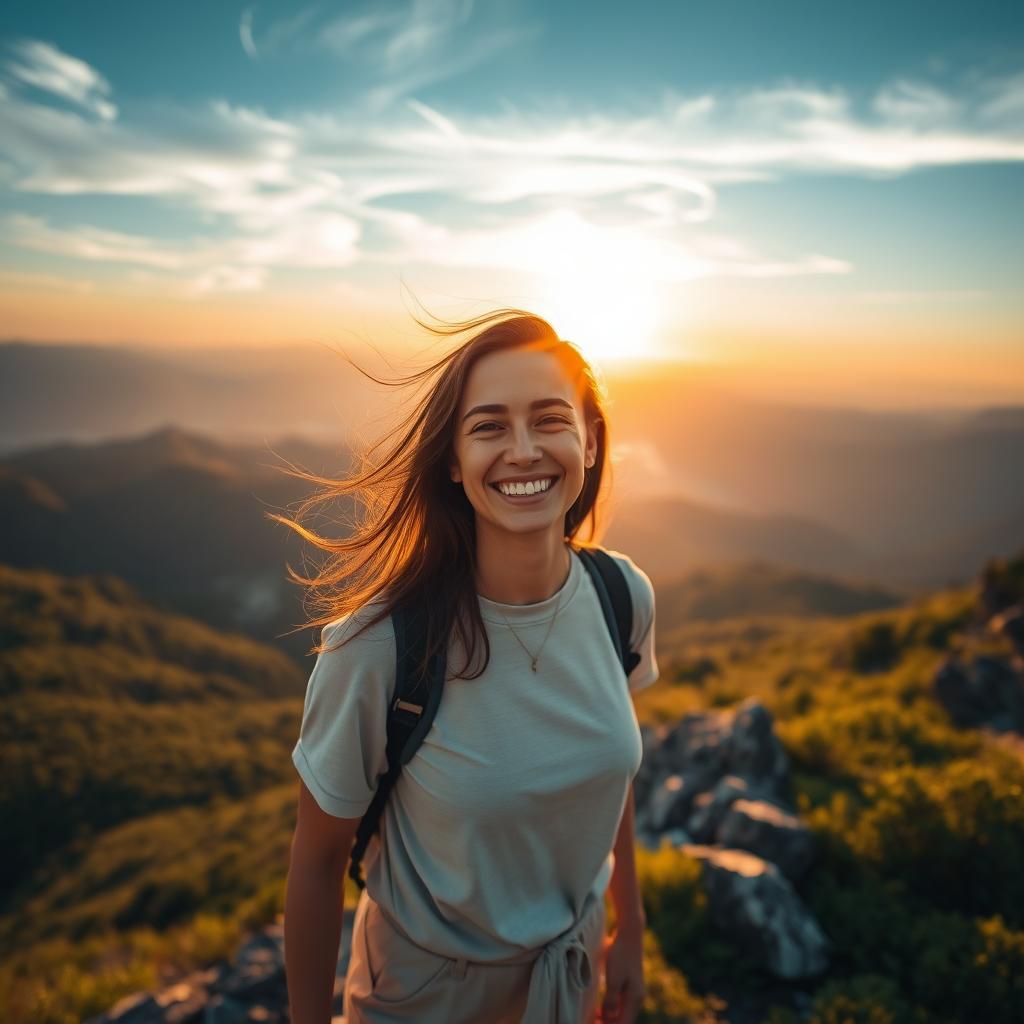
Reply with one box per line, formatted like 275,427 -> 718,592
0,343 -> 1024,622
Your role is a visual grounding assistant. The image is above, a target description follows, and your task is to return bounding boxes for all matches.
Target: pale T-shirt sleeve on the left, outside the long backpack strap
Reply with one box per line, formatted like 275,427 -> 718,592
292,613 -> 396,818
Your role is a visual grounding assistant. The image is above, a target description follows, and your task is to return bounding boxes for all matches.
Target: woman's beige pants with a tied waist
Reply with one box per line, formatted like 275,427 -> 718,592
345,890 -> 605,1024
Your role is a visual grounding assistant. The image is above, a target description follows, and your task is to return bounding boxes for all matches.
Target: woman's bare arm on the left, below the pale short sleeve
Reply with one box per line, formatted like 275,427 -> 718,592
285,779 -> 360,1024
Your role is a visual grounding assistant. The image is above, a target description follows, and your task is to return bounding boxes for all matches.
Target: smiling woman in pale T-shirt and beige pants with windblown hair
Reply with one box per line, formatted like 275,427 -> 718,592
281,309 -> 657,1024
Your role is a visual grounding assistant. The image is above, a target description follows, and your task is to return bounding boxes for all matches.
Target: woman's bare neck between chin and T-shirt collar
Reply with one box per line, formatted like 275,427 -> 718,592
476,532 -> 571,604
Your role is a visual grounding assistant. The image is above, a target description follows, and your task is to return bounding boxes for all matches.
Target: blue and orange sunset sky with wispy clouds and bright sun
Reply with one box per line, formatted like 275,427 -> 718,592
0,0 -> 1024,406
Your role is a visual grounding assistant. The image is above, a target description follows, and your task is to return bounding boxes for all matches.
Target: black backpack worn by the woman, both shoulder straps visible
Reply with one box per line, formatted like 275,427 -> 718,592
348,547 -> 640,890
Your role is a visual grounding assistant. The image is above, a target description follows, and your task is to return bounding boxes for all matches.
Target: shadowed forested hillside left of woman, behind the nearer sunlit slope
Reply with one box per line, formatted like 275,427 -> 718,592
0,567 -> 304,907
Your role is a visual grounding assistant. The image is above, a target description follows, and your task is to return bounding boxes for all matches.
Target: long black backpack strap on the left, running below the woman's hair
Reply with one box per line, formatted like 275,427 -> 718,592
348,605 -> 446,889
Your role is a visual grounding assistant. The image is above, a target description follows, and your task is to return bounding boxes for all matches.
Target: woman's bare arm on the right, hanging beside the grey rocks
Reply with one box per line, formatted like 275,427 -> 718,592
598,783 -> 646,1024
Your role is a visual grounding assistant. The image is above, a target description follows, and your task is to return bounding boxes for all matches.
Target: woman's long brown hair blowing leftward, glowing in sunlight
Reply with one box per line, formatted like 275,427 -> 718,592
267,308 -> 610,679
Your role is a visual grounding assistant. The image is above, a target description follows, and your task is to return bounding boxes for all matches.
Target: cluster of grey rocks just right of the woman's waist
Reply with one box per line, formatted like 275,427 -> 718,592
634,697 -> 829,979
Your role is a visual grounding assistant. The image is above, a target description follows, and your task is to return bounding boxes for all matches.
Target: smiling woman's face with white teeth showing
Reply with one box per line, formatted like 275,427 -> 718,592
452,348 -> 597,538
